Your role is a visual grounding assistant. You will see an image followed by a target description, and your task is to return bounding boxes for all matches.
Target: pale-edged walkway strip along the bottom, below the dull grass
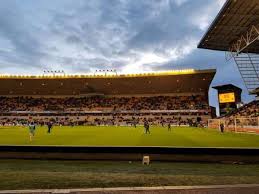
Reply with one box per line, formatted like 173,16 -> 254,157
0,184 -> 259,194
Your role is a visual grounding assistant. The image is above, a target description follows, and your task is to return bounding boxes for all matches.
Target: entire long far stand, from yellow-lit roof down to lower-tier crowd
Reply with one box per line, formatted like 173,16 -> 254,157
0,70 -> 215,125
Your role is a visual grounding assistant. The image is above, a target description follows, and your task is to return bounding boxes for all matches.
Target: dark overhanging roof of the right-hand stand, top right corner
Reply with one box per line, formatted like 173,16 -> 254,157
198,0 -> 259,53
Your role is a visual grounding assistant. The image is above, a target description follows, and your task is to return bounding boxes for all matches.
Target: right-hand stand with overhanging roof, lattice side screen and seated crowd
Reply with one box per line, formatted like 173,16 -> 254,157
198,0 -> 259,133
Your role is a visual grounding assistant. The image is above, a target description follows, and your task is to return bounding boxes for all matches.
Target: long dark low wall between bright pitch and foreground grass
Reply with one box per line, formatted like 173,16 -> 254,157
0,146 -> 259,163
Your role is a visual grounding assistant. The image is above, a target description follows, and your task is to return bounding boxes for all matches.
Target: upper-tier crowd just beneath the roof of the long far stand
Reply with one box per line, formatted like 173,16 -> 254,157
0,96 -> 209,112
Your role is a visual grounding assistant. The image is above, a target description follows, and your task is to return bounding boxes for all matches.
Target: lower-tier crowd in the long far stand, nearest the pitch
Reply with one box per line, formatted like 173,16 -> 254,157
0,115 -> 206,126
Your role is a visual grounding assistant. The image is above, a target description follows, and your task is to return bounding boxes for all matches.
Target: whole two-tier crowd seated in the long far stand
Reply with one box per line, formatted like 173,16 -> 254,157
0,95 -> 209,126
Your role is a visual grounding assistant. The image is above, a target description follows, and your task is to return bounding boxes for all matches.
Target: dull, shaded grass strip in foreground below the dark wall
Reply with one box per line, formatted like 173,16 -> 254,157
0,160 -> 259,190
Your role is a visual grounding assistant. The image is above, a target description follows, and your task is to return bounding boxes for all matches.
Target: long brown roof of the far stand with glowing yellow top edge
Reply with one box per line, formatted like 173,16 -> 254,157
0,69 -> 216,96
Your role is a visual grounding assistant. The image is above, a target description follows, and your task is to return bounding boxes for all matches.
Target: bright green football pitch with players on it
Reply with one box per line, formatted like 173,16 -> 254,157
0,126 -> 259,147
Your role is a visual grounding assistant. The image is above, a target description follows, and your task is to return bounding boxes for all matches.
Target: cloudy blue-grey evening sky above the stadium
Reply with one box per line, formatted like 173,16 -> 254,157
0,0 -> 256,109
